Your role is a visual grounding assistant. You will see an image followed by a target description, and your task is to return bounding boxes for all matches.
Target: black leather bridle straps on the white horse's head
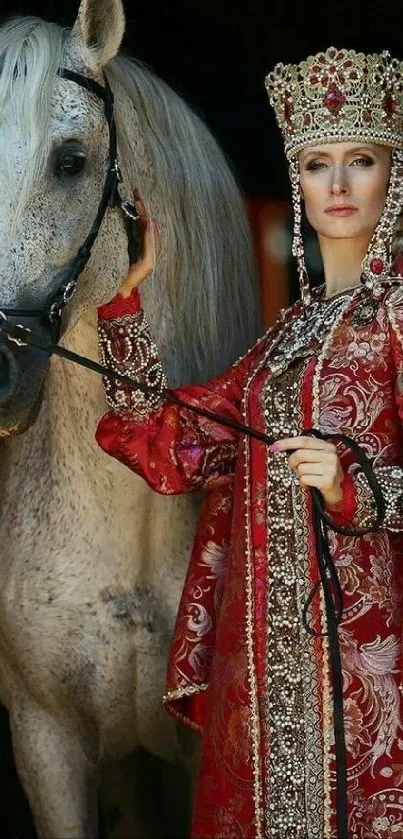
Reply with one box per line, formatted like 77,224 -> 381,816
1,68 -> 140,343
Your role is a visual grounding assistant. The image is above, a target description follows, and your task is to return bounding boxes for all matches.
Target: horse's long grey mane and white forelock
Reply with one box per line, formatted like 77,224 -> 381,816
0,17 -> 258,381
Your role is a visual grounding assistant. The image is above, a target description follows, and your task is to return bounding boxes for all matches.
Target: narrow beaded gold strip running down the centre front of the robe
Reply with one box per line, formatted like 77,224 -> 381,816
263,364 -> 307,839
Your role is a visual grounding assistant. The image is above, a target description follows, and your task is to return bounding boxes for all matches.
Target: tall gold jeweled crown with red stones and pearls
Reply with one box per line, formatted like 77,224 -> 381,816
266,47 -> 403,158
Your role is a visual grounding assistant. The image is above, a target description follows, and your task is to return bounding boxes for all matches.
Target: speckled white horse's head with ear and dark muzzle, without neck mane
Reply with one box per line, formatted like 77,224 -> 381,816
0,0 -> 137,436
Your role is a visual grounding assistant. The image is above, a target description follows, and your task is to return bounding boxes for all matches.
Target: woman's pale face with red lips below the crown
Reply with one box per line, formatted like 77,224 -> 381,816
299,143 -> 391,242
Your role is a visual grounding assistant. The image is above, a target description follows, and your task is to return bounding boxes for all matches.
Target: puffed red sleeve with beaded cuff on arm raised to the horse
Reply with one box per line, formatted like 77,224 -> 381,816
96,292 -> 266,495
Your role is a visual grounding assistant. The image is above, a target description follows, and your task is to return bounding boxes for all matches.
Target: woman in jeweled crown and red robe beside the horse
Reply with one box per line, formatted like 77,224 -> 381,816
97,48 -> 403,839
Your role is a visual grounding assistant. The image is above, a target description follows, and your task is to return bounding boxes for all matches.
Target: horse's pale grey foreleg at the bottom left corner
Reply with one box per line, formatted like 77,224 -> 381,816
10,702 -> 98,839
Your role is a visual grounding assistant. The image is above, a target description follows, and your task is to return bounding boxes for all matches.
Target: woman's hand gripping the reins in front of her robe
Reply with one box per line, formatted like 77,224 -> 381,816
270,437 -> 343,508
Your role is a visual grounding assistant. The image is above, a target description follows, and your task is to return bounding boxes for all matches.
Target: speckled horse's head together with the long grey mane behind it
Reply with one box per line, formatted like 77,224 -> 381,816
0,0 -> 259,436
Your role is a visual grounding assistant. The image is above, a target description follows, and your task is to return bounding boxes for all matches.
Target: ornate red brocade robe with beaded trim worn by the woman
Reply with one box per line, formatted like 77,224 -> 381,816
97,280 -> 403,839
